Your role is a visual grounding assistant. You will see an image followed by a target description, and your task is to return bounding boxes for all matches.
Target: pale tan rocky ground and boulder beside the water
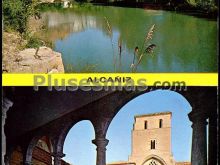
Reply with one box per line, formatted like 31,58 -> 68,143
2,32 -> 64,73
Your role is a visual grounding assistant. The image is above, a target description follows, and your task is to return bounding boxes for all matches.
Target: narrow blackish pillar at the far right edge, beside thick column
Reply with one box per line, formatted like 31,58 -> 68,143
208,114 -> 218,165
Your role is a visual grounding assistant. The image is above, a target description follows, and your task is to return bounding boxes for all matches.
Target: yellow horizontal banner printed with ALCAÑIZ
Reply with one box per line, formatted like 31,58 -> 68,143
2,73 -> 218,86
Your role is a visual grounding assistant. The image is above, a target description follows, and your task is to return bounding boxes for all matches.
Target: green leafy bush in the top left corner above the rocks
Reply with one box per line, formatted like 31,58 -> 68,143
2,0 -> 39,34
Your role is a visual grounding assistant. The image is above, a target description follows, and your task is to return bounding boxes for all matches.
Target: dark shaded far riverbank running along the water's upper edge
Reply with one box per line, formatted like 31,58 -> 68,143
37,1 -> 218,20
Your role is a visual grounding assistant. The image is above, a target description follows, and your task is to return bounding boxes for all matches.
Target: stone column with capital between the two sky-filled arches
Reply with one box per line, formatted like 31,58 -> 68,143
92,137 -> 109,165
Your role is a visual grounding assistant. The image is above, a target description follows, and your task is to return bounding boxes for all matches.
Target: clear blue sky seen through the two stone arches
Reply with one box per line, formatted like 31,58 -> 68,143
64,90 -> 192,165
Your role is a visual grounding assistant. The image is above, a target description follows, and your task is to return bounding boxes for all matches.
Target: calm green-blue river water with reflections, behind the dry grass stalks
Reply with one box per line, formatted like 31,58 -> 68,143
37,7 -> 217,72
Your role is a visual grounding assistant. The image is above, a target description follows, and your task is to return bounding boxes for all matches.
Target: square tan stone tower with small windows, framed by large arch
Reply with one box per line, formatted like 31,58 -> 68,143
129,112 -> 175,165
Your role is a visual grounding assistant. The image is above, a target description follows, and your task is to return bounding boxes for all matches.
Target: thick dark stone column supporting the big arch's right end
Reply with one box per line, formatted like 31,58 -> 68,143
190,114 -> 207,165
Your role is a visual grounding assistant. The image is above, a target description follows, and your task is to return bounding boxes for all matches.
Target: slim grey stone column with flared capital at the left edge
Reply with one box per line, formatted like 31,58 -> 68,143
2,98 -> 13,165
